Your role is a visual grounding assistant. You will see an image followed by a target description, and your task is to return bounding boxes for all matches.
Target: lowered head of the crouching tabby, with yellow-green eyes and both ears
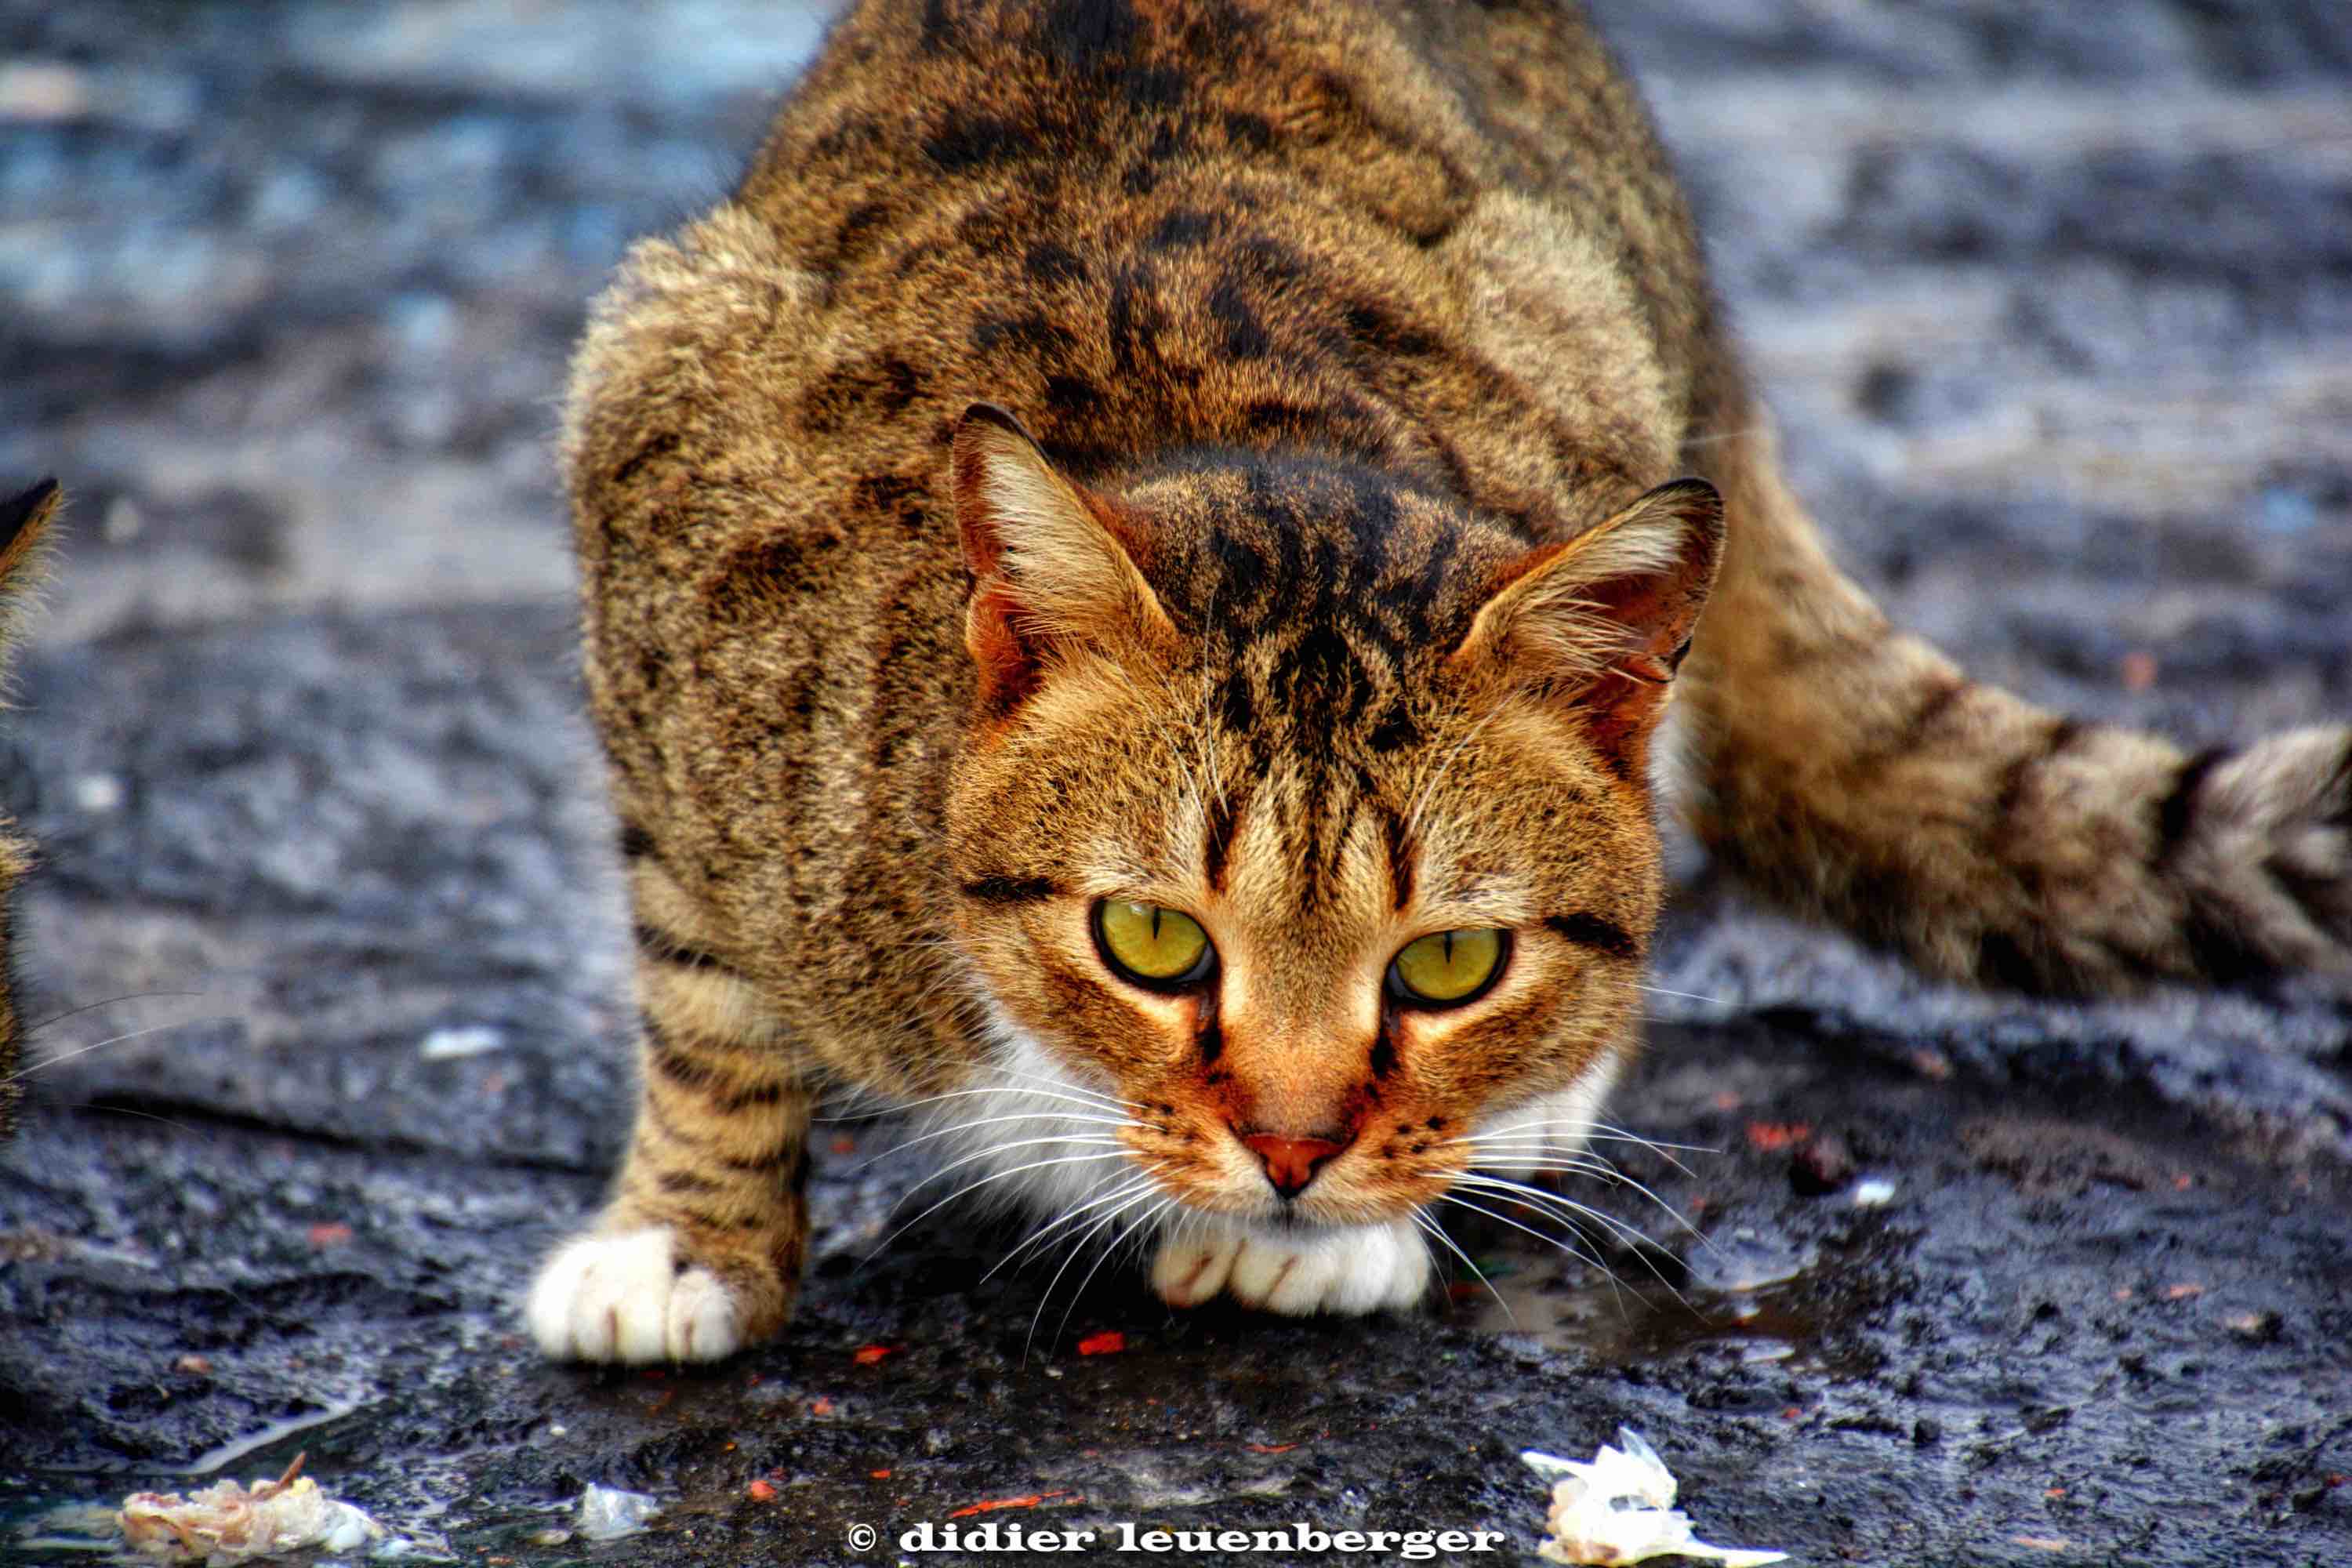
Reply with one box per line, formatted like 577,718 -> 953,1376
948,407 -> 1722,1225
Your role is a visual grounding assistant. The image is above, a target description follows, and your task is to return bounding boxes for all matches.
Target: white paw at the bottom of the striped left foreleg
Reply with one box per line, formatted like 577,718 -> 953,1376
524,1225 -> 743,1361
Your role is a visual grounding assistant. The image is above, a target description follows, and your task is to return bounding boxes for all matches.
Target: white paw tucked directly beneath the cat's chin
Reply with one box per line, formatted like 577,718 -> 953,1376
1152,1220 -> 1430,1316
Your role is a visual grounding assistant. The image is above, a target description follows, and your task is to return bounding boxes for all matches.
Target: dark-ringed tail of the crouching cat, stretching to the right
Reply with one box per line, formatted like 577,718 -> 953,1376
1677,433 -> 2352,992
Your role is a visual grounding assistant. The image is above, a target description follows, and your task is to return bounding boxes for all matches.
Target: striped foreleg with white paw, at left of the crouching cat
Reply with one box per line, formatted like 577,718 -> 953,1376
524,888 -> 814,1361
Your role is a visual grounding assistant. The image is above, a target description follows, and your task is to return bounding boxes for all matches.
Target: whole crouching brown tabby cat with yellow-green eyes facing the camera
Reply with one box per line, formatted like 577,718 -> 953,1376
527,0 -> 2352,1361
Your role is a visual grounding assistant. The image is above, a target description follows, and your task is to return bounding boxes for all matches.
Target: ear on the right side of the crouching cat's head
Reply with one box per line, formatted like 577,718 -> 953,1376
1451,480 -> 1724,764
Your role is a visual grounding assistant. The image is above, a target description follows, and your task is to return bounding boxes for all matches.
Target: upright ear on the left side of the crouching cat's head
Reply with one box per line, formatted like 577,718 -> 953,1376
953,402 -> 1176,710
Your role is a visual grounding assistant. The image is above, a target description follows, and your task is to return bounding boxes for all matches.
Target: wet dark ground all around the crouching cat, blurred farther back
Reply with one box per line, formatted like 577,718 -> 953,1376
0,0 -> 2352,1566
